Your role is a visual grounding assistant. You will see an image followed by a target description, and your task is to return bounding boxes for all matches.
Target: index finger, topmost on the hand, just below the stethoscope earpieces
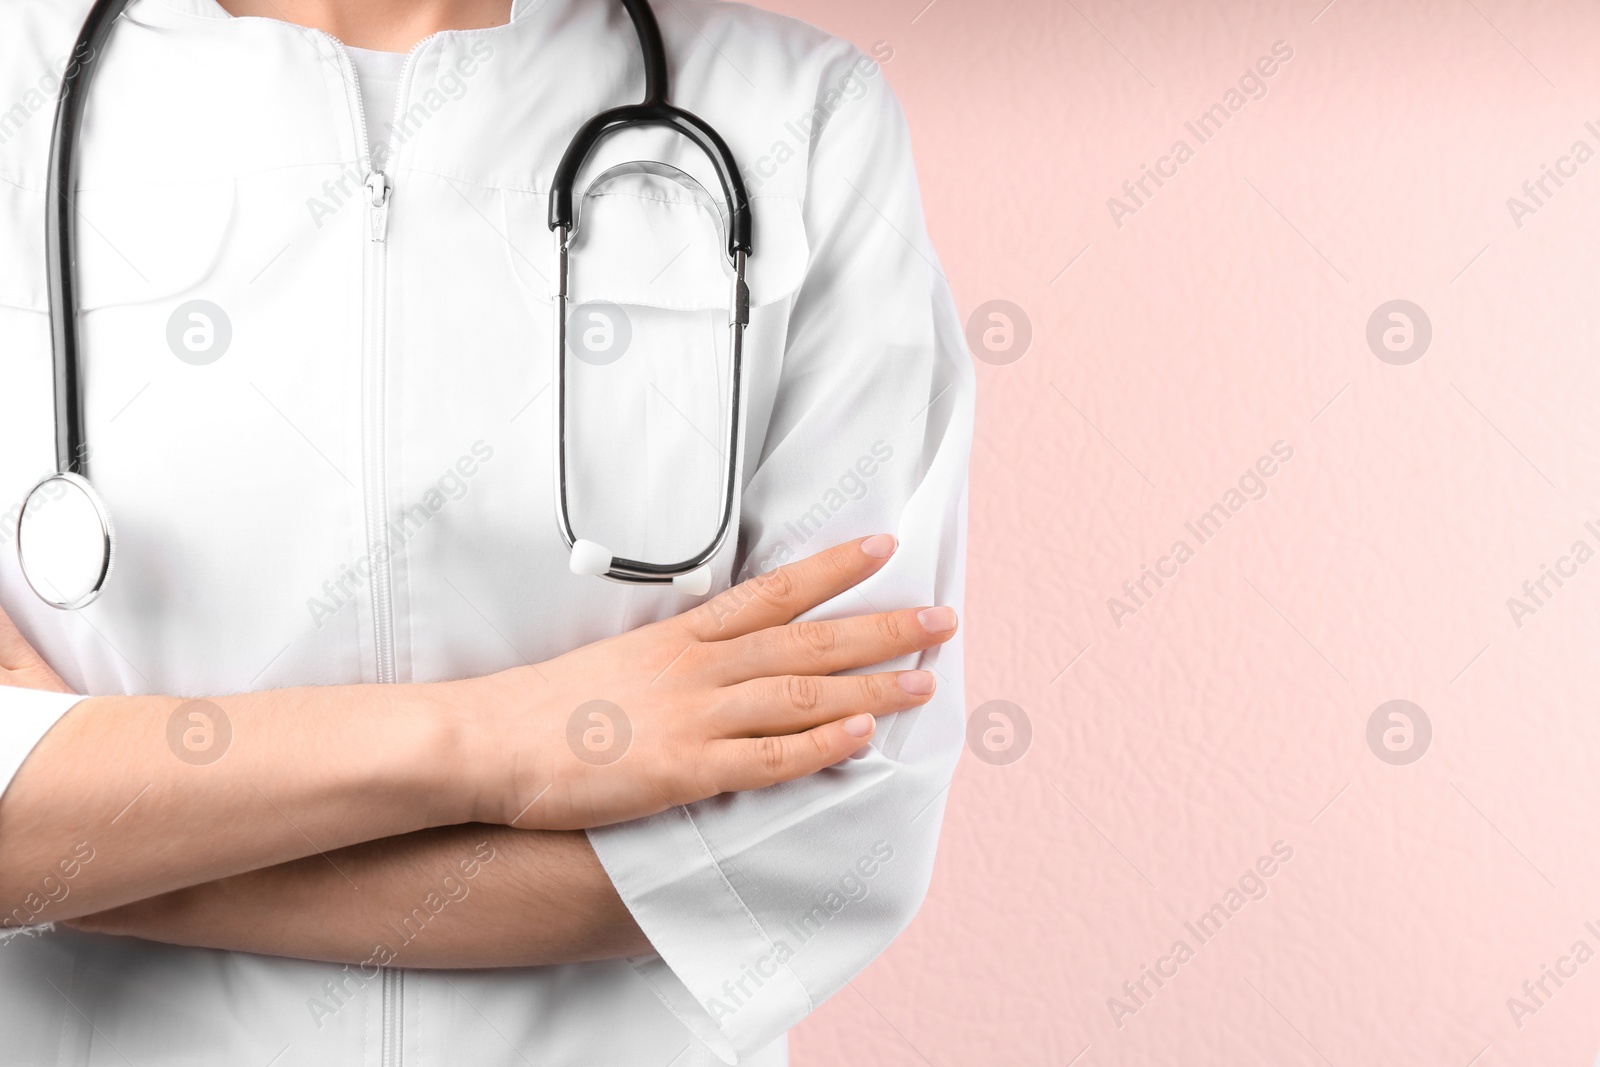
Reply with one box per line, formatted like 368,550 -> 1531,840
677,534 -> 896,641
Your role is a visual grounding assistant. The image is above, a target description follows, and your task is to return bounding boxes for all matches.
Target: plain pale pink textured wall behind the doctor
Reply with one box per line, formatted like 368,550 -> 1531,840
765,0 -> 1600,1067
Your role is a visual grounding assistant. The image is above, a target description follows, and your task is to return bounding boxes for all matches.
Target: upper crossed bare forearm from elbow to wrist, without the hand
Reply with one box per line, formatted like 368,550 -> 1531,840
0,686 -> 474,926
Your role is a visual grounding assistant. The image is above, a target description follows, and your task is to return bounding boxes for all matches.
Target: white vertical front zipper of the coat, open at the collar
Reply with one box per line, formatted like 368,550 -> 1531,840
328,34 -> 437,1067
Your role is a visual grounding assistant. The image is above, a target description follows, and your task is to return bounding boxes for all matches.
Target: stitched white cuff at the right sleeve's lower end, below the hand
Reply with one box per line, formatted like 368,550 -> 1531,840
589,808 -> 813,1064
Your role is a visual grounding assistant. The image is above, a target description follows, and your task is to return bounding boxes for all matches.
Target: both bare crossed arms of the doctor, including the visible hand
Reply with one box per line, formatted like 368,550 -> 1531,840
0,537 -> 955,968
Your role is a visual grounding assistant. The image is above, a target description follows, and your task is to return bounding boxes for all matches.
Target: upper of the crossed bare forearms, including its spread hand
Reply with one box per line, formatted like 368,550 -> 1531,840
0,536 -> 955,926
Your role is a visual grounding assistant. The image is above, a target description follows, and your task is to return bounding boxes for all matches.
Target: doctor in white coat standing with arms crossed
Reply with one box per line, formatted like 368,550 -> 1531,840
0,0 -> 973,1067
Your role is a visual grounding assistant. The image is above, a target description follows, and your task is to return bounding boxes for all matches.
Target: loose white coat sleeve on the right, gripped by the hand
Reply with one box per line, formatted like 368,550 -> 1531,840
589,45 -> 974,1064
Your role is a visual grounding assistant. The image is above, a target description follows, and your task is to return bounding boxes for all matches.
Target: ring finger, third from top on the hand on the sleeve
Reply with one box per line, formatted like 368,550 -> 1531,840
717,670 -> 934,737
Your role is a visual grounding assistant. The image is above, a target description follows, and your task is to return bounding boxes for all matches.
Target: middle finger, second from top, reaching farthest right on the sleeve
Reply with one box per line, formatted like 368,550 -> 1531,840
706,608 -> 957,685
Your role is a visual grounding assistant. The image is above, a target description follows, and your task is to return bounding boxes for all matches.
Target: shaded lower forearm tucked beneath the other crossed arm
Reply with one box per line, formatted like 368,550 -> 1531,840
74,825 -> 651,968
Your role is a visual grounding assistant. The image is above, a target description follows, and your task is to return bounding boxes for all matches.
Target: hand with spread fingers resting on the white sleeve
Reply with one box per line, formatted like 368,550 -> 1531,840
467,534 -> 957,830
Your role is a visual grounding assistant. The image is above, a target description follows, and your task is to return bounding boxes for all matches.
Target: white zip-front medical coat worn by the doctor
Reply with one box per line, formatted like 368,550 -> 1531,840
0,0 -> 973,1067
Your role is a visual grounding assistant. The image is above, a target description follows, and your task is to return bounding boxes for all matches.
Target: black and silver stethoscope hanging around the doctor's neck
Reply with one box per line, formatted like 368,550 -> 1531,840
18,0 -> 752,609
